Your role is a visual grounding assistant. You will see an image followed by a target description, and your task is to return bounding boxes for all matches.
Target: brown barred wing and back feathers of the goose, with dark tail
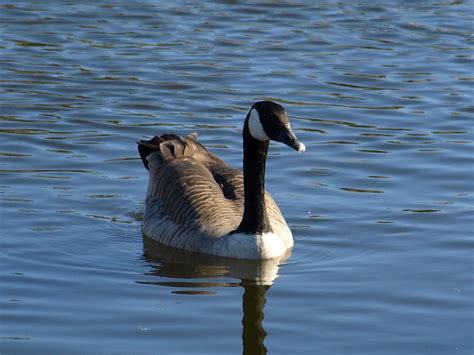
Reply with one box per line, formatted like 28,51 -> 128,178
139,135 -> 243,236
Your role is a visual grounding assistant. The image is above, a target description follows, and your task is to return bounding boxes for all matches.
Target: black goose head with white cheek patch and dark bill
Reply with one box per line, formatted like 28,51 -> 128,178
246,101 -> 306,153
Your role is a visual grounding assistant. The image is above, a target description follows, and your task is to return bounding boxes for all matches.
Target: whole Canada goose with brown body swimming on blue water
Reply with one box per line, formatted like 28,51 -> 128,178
138,101 -> 305,259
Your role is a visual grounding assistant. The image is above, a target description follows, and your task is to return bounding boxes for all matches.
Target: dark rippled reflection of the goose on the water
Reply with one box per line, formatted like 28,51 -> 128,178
139,237 -> 291,355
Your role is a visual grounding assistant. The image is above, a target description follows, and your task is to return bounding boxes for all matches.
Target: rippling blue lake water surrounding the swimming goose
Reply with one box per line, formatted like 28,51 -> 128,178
0,0 -> 474,355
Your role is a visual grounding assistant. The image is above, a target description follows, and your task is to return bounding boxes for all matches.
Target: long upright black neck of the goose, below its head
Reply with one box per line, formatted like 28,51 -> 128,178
236,118 -> 271,234
